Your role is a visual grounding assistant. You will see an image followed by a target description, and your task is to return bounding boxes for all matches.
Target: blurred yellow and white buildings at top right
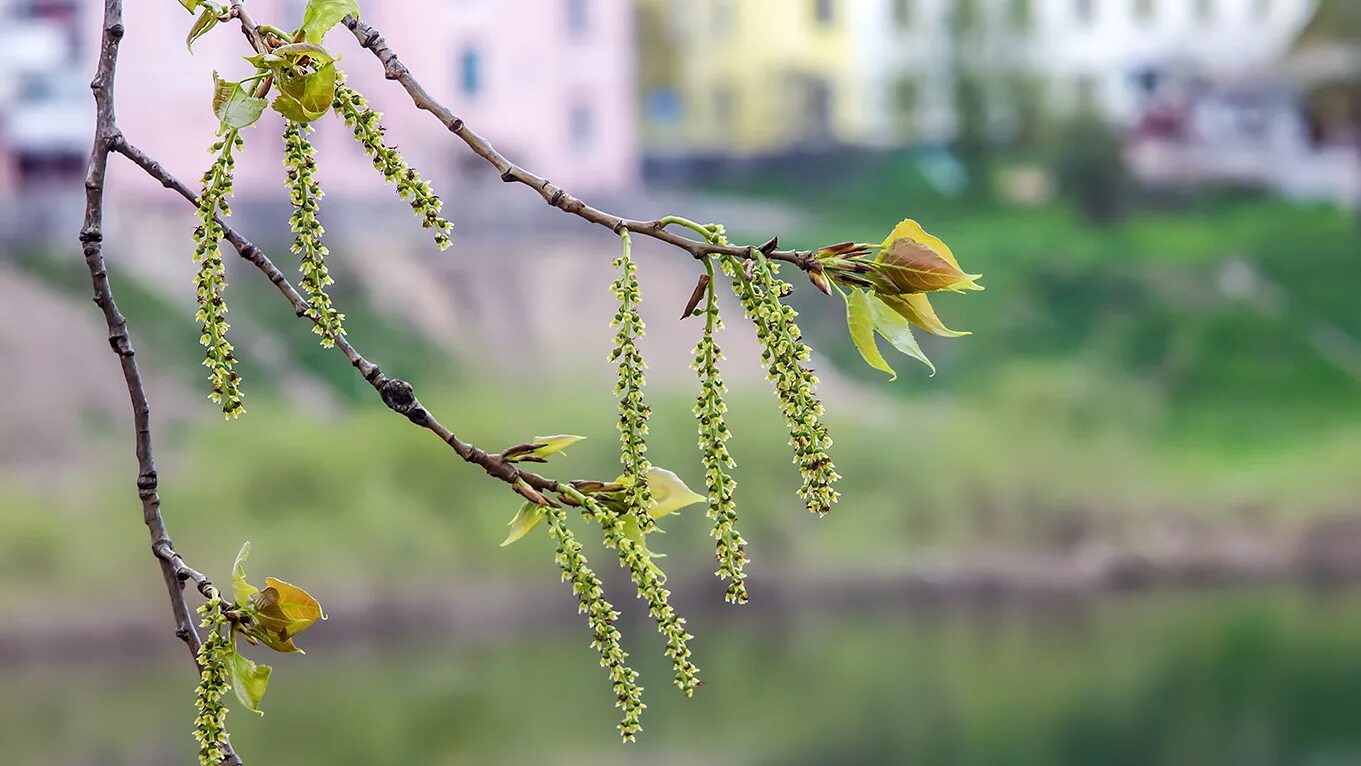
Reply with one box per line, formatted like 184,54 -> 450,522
640,0 -> 1315,163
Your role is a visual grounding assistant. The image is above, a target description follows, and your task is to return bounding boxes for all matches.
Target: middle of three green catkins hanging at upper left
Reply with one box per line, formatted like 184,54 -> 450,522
283,120 -> 344,348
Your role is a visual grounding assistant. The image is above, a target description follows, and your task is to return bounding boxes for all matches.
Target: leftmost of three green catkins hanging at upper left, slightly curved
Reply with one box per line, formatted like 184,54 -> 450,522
193,131 -> 245,419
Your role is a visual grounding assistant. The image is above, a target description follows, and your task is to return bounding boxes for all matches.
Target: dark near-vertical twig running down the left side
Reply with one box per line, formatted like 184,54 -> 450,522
80,0 -> 241,766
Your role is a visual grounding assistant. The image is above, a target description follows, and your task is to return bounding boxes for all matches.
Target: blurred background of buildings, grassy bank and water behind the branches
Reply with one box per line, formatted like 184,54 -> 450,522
0,0 -> 1361,766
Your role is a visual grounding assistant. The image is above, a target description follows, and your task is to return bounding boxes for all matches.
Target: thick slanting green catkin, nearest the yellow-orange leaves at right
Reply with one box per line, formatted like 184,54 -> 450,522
723,252 -> 841,516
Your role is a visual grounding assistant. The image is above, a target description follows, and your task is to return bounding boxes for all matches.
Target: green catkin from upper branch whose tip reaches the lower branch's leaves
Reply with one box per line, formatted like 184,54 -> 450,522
610,231 -> 656,532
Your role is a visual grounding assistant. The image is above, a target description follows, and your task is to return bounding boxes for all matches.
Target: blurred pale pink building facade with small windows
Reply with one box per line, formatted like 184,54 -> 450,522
0,0 -> 638,200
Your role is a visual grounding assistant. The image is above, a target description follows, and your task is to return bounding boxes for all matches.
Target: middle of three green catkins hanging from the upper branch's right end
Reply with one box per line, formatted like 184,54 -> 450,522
693,261 -> 747,604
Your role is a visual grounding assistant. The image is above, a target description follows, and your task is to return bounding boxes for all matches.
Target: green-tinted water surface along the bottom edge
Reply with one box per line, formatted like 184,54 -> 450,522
0,592 -> 1361,766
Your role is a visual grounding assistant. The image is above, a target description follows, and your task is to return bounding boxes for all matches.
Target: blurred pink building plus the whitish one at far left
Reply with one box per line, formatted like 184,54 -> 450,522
0,0 -> 638,219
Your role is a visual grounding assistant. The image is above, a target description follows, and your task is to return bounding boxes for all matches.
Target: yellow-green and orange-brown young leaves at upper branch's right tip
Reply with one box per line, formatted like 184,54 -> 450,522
810,220 -> 983,377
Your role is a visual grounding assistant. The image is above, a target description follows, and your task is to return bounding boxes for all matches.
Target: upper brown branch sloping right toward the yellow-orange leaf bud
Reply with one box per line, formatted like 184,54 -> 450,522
343,16 -> 819,271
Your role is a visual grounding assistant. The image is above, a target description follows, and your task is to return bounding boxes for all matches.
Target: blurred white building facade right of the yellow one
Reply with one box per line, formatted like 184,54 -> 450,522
844,0 -> 1315,146
